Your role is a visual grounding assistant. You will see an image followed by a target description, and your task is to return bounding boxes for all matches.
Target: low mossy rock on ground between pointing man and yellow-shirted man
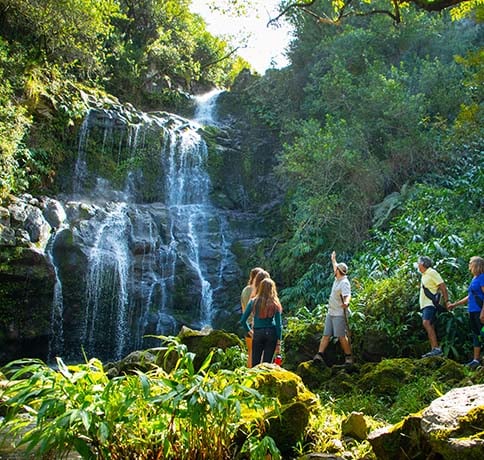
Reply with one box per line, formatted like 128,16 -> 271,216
359,358 -> 415,396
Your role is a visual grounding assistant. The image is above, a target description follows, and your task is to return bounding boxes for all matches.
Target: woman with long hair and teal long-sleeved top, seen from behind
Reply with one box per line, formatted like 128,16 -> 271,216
240,278 -> 282,367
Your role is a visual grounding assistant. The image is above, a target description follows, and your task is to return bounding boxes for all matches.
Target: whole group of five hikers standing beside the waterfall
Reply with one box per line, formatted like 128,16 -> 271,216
240,251 -> 484,368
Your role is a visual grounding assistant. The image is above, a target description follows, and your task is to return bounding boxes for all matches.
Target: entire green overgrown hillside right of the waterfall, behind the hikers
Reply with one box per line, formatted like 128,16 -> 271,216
215,2 -> 484,360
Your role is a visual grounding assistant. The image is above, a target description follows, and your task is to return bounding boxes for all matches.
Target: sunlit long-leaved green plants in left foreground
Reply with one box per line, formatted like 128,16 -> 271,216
2,342 -> 278,459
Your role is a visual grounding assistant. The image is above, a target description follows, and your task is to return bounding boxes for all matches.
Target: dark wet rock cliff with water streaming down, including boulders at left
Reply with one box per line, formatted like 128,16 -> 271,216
0,95 -> 276,360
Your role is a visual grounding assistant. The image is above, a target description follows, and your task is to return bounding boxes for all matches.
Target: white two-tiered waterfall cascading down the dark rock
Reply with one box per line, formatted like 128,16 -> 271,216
51,93 -> 238,359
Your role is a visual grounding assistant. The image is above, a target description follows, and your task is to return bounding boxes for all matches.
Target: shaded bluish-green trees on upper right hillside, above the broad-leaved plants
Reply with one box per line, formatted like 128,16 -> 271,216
229,2 -> 482,305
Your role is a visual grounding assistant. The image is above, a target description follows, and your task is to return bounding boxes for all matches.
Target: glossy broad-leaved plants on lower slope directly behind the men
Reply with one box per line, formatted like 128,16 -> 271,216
283,145 -> 484,361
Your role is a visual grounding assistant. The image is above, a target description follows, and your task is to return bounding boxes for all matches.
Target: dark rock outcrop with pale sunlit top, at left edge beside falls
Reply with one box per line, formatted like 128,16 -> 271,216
0,195 -> 55,364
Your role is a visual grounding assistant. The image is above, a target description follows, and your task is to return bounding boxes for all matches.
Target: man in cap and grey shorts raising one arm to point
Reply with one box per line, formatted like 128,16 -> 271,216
313,251 -> 353,364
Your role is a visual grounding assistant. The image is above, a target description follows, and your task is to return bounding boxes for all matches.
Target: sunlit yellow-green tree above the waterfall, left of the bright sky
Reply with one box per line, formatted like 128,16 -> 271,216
107,0 -> 246,109
